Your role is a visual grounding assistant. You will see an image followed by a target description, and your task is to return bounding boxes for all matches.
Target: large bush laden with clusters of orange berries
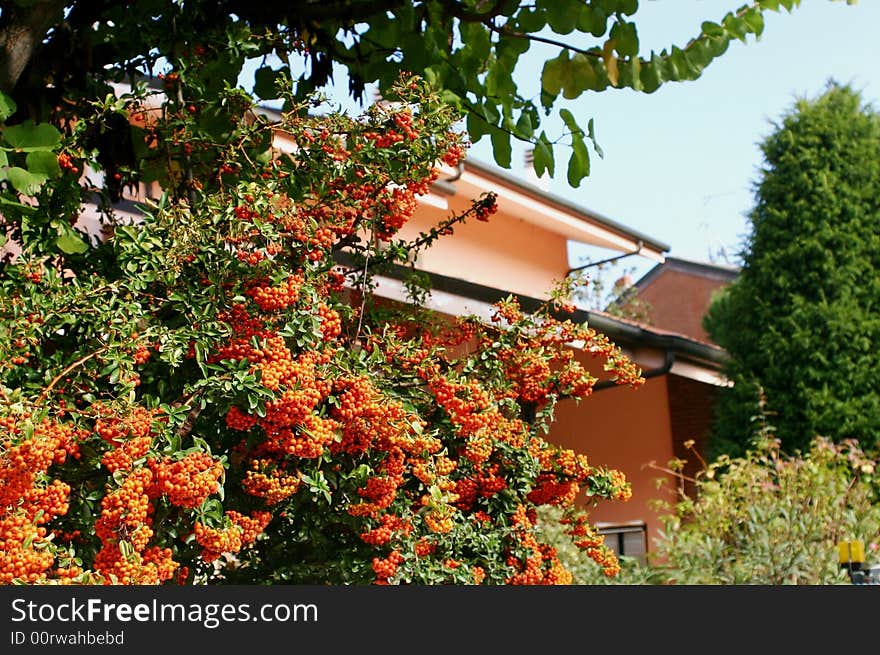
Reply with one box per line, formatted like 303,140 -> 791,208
0,55 -> 642,584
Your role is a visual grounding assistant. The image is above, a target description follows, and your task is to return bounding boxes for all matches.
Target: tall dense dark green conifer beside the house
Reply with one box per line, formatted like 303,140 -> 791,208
705,84 -> 880,453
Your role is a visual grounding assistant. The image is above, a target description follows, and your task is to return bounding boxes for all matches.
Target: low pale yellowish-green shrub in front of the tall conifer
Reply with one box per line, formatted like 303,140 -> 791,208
651,432 -> 880,585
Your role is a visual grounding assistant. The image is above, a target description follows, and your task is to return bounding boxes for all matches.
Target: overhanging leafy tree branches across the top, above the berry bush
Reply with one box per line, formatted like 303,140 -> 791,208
0,0 -> 840,193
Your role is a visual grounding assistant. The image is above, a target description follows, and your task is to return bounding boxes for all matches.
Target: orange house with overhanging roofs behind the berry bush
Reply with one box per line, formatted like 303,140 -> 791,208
376,160 -> 730,557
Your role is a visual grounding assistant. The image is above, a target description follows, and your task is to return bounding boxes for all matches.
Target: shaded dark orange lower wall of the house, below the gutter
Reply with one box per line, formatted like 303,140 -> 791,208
548,348 -> 675,551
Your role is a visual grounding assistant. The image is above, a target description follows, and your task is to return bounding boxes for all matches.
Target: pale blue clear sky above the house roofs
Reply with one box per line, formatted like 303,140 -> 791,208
470,0 -> 880,277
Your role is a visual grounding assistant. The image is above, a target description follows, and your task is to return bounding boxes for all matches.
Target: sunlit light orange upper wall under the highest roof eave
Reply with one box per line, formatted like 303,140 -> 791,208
399,196 -> 568,298
